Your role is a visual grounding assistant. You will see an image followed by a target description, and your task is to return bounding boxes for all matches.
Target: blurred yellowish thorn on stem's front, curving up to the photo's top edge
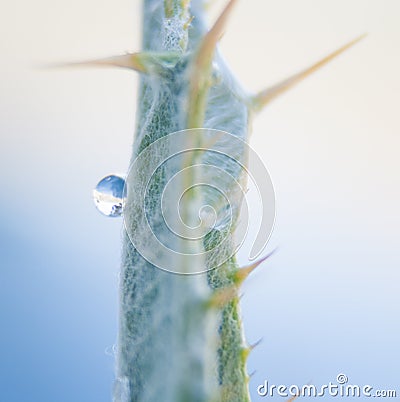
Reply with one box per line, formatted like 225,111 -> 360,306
187,0 -> 237,128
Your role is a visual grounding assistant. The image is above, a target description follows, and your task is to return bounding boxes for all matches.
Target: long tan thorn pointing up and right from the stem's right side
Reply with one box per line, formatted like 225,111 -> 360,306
251,34 -> 367,111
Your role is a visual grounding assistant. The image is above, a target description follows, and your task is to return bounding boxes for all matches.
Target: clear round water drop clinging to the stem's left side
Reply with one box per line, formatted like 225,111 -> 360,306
93,174 -> 125,218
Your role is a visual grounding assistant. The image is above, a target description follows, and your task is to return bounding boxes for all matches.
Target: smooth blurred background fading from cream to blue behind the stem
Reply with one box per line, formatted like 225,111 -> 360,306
0,0 -> 400,402
